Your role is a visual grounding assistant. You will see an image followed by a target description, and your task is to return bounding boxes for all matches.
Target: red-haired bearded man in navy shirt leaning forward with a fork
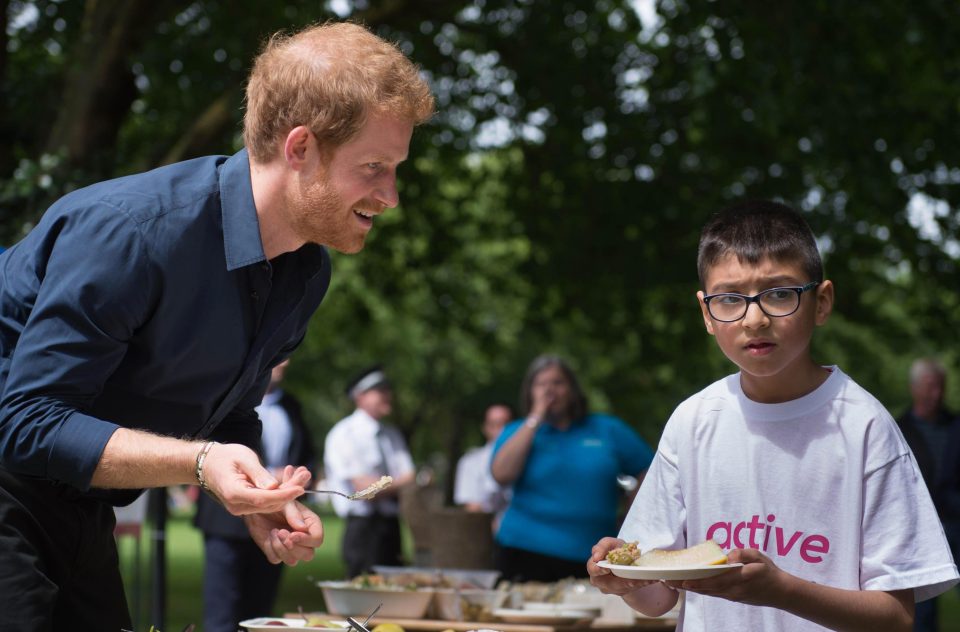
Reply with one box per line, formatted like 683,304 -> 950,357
0,23 -> 434,630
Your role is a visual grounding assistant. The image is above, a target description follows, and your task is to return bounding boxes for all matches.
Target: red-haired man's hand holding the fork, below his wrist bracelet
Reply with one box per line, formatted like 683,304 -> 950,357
203,443 -> 310,516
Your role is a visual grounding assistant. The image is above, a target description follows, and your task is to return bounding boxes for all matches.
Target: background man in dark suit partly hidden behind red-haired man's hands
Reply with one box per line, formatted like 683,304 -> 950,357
194,360 -> 315,632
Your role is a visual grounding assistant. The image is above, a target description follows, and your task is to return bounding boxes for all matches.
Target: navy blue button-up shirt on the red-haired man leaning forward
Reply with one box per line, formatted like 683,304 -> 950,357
0,151 -> 330,496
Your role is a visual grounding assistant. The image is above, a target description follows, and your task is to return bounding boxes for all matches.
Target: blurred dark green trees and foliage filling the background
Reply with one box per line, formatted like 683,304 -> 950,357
0,0 -> 960,484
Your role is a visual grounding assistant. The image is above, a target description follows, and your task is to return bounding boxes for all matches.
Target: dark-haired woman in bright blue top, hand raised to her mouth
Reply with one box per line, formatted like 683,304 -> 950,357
491,355 -> 653,582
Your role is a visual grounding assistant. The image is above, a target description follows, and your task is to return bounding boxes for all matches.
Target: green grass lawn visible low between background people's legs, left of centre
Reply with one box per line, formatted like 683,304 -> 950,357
119,514 -> 362,632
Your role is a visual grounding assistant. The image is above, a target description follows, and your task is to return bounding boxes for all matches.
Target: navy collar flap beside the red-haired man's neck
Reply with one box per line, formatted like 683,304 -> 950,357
220,149 -> 266,271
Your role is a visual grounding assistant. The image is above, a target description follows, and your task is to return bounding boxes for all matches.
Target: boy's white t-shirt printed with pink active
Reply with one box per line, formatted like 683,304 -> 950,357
620,367 -> 958,632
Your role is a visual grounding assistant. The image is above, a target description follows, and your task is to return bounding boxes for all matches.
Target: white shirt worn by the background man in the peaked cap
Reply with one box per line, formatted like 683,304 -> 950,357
323,408 -> 414,516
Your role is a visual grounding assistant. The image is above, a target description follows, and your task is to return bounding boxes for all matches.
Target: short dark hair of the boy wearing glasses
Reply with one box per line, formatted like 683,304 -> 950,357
697,200 -> 823,289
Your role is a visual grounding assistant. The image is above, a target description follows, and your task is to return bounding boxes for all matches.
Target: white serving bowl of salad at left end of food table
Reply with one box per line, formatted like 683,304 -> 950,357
317,581 -> 433,619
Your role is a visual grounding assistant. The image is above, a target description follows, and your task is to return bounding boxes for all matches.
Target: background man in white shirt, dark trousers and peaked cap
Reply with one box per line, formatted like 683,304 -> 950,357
324,366 -> 415,577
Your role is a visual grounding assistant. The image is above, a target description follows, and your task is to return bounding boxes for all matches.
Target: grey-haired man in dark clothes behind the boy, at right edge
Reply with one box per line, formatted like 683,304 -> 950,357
897,358 -> 960,632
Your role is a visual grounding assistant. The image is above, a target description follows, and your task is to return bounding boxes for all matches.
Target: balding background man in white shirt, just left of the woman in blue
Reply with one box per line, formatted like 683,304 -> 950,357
453,404 -> 513,529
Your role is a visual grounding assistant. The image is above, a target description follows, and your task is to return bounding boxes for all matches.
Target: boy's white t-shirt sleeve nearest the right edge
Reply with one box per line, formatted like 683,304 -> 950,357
860,454 -> 957,601
